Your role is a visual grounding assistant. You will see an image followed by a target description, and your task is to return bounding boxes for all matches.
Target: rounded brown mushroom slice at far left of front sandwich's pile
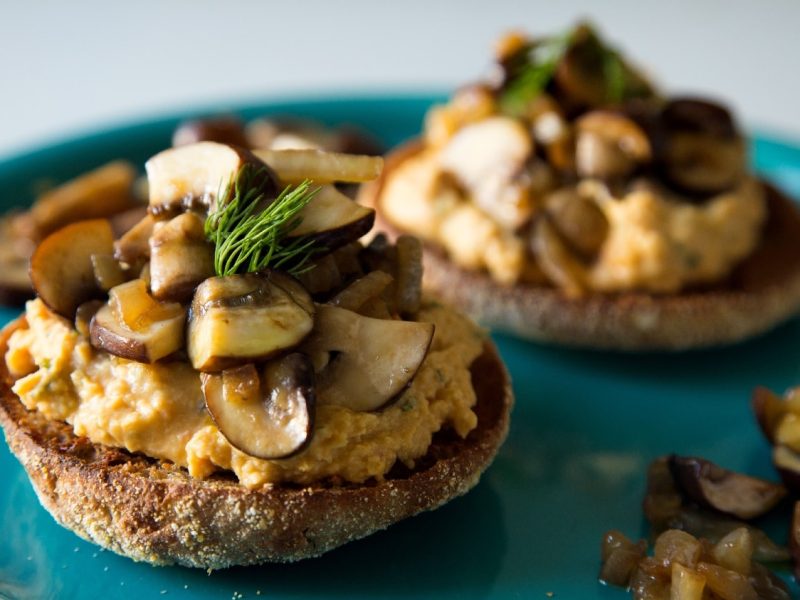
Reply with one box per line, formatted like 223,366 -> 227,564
30,219 -> 114,320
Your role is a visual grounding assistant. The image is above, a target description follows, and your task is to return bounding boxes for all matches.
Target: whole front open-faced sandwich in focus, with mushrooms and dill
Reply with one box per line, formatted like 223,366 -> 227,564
0,142 -> 512,568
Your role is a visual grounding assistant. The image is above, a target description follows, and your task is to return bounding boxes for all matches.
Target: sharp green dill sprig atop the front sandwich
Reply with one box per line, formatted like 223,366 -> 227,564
205,164 -> 319,276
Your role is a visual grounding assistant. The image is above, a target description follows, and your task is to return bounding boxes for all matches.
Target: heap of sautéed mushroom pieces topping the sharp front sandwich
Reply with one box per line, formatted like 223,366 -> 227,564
30,142 -> 434,459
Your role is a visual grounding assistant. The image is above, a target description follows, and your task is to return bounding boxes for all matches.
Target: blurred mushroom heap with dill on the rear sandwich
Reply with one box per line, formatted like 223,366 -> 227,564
420,25 -> 747,295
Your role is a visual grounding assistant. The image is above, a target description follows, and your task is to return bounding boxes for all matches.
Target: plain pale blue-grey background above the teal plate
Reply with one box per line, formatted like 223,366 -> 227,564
0,0 -> 800,157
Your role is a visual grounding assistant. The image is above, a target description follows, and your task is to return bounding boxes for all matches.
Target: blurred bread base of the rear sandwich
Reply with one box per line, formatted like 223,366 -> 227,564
359,143 -> 800,351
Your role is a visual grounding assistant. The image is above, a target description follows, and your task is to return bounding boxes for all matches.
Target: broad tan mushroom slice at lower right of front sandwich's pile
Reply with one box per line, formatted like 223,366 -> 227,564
302,305 -> 434,411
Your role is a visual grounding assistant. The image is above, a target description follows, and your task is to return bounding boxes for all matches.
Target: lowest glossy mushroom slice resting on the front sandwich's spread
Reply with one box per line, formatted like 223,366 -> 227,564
201,353 -> 315,460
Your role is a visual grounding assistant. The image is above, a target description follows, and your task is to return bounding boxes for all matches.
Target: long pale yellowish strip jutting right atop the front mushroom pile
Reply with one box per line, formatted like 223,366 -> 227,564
253,150 -> 383,185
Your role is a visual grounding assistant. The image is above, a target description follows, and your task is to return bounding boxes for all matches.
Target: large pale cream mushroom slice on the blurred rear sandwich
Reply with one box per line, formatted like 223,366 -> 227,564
439,117 -> 533,229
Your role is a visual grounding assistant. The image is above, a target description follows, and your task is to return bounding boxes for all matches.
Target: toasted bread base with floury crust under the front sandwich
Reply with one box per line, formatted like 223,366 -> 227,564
0,318 -> 513,569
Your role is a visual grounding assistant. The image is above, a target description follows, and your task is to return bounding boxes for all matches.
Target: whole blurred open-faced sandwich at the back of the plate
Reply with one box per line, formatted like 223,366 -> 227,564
362,25 -> 800,350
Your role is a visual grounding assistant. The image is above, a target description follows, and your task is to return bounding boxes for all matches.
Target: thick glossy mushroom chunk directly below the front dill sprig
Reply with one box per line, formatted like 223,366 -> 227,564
188,271 -> 314,372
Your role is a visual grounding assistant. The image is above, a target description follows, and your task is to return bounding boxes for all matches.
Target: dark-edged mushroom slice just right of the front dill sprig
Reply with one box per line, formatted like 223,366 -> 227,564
290,185 -> 375,251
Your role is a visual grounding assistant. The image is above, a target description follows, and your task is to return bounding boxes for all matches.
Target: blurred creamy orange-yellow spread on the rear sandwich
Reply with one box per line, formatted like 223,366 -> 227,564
380,148 -> 767,293
